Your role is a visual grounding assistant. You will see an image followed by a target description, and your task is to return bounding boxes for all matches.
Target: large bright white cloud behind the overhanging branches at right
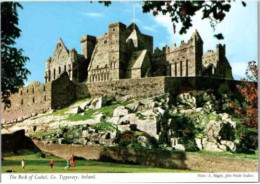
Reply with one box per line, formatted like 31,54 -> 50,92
151,2 -> 257,79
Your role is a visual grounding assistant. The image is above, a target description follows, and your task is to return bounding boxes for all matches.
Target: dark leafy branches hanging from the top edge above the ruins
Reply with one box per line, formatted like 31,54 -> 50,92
99,0 -> 246,39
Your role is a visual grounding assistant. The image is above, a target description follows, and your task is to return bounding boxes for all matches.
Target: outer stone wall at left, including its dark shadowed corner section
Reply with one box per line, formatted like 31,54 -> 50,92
1,72 -> 76,123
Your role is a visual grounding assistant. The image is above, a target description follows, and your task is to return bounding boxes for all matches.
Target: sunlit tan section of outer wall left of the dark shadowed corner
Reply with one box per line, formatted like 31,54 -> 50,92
1,82 -> 51,123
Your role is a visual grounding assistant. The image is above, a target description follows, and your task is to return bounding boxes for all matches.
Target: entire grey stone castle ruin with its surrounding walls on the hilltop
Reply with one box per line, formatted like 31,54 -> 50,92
1,22 -> 236,123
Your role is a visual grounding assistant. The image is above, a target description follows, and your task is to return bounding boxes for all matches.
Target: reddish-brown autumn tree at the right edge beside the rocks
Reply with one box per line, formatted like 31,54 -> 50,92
235,61 -> 258,128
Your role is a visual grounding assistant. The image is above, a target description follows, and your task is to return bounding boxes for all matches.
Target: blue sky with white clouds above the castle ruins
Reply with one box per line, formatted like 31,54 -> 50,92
17,1 -> 257,85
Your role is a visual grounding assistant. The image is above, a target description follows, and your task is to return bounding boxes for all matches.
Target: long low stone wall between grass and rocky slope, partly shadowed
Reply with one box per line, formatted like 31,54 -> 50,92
33,140 -> 258,172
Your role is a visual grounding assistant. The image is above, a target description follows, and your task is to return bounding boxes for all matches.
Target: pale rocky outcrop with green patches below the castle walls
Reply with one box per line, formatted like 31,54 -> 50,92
3,91 -> 244,152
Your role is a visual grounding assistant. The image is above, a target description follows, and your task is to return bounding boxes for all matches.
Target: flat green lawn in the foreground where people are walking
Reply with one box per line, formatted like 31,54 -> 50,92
2,153 -> 191,173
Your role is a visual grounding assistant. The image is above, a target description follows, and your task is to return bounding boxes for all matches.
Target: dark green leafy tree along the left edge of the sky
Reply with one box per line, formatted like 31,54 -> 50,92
1,2 -> 30,108
